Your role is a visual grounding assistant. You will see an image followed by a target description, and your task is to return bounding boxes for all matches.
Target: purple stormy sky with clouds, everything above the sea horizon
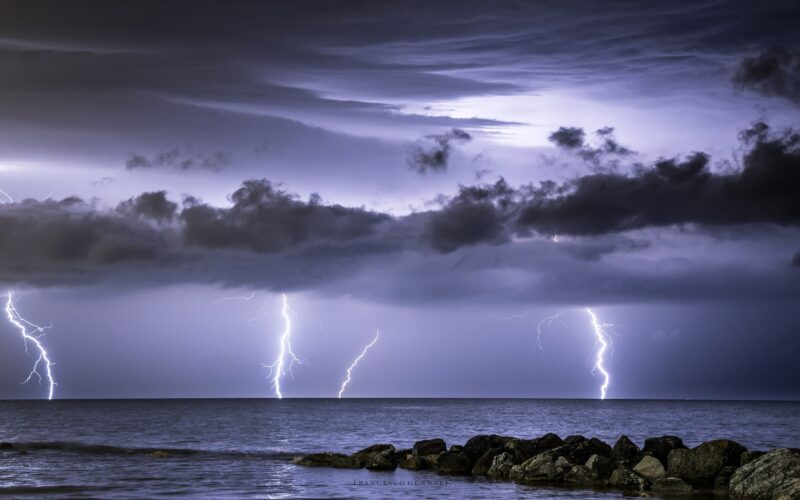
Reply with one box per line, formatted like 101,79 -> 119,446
0,0 -> 800,399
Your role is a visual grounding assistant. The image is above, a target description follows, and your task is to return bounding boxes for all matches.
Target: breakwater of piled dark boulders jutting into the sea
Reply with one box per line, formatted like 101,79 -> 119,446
294,434 -> 800,500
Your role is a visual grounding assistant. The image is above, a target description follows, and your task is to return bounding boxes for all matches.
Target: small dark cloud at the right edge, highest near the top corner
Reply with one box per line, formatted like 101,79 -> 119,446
733,48 -> 800,104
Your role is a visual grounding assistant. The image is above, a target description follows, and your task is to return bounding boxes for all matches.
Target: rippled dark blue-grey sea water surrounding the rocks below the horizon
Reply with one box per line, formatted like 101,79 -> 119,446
0,399 -> 800,499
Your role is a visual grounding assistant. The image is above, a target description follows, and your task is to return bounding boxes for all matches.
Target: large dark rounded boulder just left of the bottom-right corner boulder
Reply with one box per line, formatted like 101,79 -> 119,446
667,439 -> 745,488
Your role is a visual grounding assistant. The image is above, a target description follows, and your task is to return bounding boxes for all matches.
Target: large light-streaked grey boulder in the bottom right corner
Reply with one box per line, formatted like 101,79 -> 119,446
728,448 -> 800,500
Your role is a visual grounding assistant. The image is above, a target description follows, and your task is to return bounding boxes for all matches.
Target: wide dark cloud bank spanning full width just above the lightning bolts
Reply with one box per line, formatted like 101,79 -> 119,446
0,124 -> 800,302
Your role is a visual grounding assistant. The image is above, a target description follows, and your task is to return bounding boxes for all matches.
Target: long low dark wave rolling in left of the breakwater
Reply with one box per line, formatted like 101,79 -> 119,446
0,441 -> 302,460
